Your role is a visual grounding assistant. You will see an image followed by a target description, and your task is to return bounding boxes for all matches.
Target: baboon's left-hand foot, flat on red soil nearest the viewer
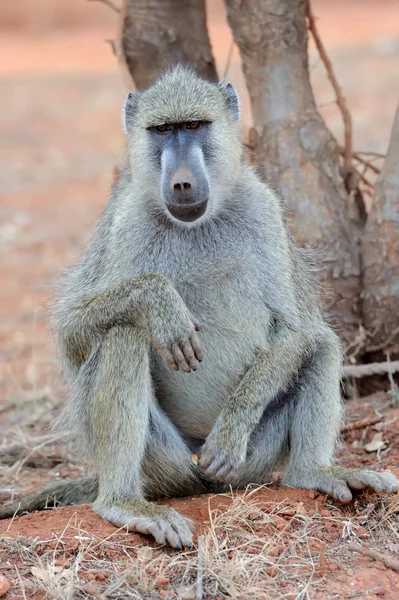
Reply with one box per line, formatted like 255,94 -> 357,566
93,498 -> 194,549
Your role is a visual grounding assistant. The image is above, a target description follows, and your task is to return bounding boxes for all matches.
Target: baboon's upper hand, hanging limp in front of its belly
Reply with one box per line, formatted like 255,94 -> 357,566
149,284 -> 203,373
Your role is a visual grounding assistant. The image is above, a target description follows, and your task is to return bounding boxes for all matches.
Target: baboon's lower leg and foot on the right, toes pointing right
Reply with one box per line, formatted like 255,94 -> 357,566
283,337 -> 399,503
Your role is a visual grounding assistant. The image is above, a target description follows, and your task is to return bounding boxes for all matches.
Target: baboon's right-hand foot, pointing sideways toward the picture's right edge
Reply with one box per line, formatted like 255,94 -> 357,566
283,466 -> 399,504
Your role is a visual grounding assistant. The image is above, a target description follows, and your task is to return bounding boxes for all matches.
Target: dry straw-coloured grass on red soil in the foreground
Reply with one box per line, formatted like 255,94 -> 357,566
0,491 -> 399,600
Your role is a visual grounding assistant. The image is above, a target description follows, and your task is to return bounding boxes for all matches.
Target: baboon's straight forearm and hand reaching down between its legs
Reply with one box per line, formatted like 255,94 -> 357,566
199,325 -> 311,482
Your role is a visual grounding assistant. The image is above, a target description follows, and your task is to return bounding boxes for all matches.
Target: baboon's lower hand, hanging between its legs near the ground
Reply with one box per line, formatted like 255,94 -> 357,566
198,426 -> 248,483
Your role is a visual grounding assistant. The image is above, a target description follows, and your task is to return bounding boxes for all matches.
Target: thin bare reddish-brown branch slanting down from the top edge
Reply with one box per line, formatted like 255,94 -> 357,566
306,0 -> 353,171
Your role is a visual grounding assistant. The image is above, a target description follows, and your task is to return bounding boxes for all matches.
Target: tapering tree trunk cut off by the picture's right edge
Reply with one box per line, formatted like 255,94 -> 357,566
362,106 -> 399,354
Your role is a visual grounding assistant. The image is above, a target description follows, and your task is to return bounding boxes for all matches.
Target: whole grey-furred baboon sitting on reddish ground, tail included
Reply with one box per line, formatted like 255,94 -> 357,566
1,66 -> 398,548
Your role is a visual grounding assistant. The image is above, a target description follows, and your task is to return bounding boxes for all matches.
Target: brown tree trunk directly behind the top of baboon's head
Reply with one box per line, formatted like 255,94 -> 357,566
119,0 -> 218,89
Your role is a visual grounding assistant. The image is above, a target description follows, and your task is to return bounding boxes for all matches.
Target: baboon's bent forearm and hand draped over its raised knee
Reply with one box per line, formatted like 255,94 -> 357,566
58,273 -> 202,371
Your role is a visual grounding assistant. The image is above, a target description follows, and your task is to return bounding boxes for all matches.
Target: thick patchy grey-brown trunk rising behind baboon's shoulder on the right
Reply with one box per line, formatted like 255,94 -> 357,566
225,0 -> 361,340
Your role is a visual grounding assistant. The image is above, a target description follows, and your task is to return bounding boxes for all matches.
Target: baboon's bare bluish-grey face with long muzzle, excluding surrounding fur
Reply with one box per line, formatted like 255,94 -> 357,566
148,121 -> 211,222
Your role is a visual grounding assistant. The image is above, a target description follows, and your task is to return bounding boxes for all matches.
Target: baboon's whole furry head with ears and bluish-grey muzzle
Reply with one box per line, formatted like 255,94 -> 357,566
124,66 -> 242,224
